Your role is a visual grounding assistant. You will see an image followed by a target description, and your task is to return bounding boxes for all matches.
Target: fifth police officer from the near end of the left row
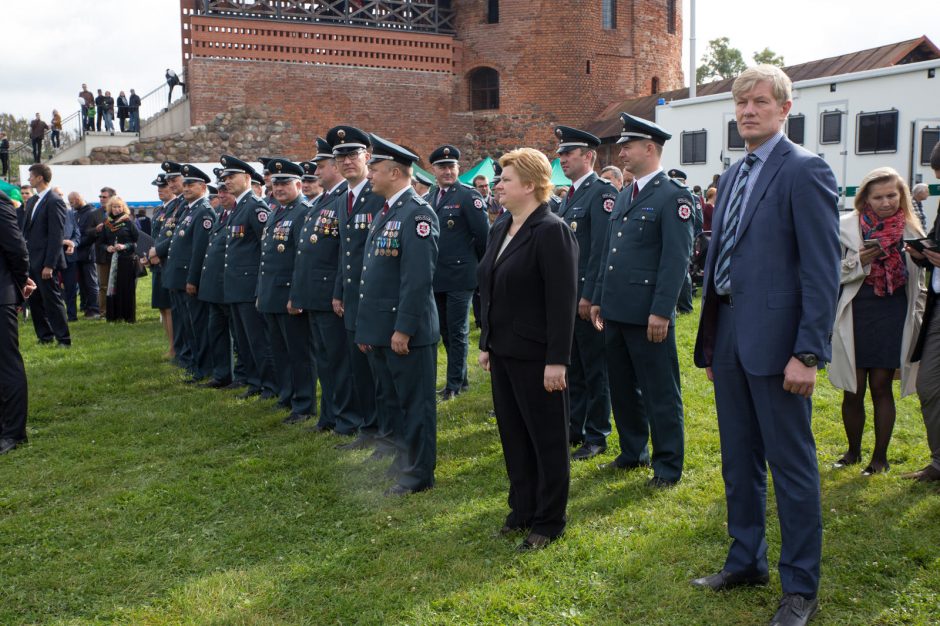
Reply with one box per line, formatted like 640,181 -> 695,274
219,154 -> 277,400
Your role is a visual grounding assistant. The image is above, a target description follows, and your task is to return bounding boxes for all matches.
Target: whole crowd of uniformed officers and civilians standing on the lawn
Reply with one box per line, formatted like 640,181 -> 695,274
0,66 -> 940,626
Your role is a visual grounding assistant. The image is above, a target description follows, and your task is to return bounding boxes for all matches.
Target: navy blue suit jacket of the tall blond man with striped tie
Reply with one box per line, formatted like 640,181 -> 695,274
695,137 -> 840,376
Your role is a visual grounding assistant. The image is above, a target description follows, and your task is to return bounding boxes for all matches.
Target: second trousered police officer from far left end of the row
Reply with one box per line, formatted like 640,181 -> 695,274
163,163 -> 216,382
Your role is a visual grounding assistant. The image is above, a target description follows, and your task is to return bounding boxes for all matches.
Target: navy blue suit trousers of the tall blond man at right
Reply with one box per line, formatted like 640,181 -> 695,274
712,304 -> 822,598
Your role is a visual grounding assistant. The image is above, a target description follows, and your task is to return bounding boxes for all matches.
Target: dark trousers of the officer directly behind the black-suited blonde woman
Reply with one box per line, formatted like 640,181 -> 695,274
568,317 -> 610,446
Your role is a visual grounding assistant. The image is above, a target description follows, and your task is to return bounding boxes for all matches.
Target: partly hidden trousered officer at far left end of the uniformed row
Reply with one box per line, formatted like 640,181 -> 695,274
148,161 -> 193,372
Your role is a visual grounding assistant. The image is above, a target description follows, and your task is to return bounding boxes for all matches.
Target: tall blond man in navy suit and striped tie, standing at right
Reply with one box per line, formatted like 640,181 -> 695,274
693,65 -> 840,626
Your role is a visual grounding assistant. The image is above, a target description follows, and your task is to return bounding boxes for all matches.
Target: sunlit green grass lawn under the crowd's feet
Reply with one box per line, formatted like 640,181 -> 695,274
0,280 -> 940,625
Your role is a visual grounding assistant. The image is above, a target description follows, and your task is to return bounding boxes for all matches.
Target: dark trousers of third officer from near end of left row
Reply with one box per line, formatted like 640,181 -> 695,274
304,311 -> 359,435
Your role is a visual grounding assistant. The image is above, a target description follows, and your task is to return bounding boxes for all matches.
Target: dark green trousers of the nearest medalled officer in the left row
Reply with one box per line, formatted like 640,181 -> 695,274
369,345 -> 437,491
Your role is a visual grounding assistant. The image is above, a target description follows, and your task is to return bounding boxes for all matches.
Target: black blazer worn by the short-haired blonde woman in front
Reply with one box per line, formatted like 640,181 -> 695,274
477,204 -> 578,365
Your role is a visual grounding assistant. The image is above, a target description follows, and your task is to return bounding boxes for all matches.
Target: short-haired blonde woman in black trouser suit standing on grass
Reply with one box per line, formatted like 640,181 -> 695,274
477,148 -> 578,550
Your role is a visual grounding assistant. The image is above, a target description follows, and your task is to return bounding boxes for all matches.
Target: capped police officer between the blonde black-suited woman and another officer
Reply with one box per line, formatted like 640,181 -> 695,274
555,126 -> 617,460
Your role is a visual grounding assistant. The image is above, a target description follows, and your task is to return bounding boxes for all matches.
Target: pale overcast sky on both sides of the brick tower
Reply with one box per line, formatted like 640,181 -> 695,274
0,0 -> 940,119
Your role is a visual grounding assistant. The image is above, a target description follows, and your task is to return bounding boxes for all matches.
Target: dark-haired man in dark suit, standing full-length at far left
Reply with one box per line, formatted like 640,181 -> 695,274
23,163 -> 72,348
